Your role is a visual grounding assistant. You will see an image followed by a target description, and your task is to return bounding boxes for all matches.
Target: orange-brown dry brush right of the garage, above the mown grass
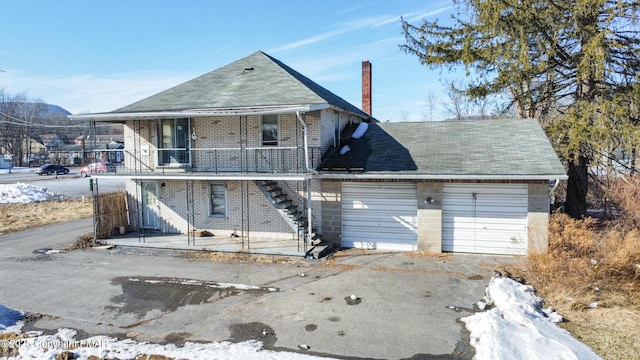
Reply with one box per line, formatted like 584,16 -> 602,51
524,214 -> 640,308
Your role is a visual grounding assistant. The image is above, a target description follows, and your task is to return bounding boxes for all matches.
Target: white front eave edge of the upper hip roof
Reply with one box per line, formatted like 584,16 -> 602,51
69,104 -> 331,122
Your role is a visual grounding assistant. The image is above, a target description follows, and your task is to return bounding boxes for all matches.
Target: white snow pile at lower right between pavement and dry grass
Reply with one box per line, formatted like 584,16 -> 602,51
462,277 -> 601,360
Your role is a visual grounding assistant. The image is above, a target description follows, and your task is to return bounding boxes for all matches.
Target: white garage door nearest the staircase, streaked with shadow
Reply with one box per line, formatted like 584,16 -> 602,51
342,182 -> 418,251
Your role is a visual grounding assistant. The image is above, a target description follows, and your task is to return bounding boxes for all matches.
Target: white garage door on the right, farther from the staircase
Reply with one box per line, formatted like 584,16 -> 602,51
442,184 -> 527,255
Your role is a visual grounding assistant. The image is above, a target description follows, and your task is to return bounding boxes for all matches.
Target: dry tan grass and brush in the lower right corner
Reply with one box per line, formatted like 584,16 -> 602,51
512,214 -> 640,359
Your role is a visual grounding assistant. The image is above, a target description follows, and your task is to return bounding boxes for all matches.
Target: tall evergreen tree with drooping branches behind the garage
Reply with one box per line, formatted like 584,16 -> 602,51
401,0 -> 640,218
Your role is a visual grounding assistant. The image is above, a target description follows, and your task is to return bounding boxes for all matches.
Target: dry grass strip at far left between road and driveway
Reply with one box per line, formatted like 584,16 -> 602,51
0,200 -> 93,233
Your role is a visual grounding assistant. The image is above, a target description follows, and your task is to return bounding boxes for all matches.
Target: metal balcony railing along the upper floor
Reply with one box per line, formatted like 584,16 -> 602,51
118,147 -> 322,174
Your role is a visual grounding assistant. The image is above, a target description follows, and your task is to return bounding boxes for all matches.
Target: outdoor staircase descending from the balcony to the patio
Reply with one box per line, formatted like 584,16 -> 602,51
255,180 -> 333,259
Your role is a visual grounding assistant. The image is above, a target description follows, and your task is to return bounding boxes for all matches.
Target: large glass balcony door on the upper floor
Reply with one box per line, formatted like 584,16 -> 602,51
158,119 -> 189,165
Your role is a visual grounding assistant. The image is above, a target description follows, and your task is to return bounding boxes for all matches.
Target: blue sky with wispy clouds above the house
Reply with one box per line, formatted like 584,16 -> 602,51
0,0 -> 453,121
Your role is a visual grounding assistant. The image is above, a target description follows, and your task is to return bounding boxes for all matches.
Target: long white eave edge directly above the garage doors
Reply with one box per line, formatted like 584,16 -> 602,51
315,173 -> 568,181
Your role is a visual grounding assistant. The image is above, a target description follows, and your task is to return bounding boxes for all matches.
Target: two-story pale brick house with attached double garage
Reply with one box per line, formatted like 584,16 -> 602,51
73,52 -> 566,254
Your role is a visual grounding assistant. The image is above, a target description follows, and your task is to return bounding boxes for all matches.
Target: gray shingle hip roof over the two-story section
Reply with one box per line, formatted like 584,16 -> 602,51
112,51 -> 368,117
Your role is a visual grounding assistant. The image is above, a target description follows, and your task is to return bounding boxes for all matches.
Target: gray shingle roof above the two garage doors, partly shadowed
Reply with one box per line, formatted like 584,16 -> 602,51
320,119 -> 566,179
